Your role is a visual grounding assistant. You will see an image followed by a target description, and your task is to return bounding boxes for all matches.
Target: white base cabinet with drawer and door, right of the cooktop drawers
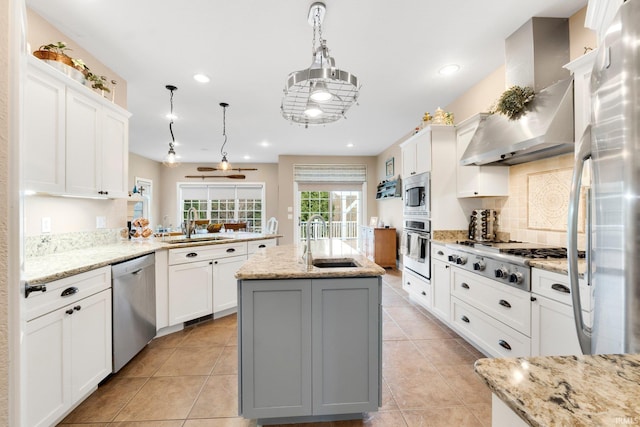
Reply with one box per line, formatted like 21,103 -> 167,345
531,268 -> 591,356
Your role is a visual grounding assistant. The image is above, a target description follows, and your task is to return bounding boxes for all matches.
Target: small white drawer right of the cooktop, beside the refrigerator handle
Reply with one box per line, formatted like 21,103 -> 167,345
531,268 -> 593,311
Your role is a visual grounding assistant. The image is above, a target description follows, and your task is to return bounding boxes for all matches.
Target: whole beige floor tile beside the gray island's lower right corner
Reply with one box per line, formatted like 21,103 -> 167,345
387,374 -> 462,409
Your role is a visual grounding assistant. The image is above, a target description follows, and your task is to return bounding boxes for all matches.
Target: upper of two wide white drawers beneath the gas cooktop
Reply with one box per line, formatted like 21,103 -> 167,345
452,267 -> 531,336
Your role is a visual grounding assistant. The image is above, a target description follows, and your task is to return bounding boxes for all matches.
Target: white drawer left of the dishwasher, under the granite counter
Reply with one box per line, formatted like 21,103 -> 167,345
25,266 -> 111,321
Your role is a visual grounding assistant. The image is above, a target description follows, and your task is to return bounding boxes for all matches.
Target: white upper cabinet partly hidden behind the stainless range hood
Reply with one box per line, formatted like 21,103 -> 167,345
456,113 -> 509,198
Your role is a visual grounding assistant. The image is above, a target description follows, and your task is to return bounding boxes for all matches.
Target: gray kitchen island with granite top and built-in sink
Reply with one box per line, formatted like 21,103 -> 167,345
236,240 -> 384,425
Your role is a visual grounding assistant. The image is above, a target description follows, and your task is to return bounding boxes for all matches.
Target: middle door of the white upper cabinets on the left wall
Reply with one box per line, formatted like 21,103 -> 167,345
66,89 -> 102,195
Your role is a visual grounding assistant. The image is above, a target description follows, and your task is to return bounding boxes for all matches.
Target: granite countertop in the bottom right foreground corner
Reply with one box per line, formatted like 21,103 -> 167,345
475,354 -> 640,426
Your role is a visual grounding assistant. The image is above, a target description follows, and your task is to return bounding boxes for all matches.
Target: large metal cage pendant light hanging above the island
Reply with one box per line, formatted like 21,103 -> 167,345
280,2 -> 360,127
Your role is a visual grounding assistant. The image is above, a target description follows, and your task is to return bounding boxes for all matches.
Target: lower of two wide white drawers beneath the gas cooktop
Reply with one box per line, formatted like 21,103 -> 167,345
451,297 -> 531,357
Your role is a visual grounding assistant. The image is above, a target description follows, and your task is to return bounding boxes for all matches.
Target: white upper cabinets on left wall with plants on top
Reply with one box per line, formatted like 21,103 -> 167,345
23,57 -> 130,198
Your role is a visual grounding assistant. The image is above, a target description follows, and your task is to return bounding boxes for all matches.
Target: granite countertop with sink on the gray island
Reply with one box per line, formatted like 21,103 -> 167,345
236,240 -> 385,280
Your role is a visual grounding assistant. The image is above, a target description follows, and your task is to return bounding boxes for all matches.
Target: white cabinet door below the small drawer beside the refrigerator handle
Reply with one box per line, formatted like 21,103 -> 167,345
531,294 -> 589,356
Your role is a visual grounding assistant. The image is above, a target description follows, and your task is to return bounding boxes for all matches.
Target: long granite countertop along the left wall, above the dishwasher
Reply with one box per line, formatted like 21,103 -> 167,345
23,232 -> 282,284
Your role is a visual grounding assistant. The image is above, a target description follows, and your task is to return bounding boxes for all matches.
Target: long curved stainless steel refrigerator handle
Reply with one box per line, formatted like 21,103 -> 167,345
567,125 -> 591,354
